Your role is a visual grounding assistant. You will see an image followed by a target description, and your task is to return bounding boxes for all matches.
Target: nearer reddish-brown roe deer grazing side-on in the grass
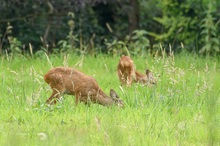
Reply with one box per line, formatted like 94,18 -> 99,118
44,67 -> 124,107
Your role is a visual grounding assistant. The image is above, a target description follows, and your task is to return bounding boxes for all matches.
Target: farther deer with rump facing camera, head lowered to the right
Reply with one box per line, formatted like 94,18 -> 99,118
117,55 -> 156,86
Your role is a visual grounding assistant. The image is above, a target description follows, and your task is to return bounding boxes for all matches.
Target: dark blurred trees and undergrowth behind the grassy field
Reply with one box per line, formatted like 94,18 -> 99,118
0,0 -> 220,56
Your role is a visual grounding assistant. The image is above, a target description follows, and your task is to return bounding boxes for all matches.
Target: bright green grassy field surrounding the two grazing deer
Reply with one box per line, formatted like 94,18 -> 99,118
0,53 -> 220,146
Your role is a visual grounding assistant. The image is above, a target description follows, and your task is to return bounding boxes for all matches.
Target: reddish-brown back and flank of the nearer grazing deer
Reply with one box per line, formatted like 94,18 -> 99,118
44,67 -> 99,94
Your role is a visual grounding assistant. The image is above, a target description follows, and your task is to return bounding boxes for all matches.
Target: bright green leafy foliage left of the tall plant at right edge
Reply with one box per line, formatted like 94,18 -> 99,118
150,0 -> 201,50
